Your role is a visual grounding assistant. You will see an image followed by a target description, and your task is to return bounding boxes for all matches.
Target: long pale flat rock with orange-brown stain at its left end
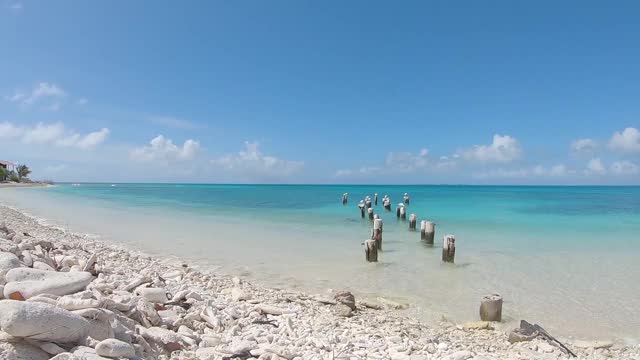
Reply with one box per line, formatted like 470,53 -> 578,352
4,268 -> 93,299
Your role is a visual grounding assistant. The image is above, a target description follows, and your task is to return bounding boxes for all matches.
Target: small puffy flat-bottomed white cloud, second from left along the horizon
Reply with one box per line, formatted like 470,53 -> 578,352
131,135 -> 200,162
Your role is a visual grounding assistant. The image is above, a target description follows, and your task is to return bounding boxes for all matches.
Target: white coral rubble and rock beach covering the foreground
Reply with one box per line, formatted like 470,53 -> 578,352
0,206 -> 640,360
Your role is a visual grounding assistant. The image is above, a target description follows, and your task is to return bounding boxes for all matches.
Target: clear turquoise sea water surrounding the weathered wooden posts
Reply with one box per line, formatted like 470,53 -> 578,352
0,184 -> 640,341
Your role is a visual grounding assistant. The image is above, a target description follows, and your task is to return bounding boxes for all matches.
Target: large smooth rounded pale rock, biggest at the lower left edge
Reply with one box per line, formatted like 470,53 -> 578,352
0,300 -> 89,343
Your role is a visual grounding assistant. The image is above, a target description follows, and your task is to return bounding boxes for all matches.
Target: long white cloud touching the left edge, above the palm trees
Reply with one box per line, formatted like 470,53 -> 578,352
0,122 -> 109,149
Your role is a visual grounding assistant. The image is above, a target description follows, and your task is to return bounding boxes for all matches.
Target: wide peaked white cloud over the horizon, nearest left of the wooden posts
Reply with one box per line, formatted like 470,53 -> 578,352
211,141 -> 304,176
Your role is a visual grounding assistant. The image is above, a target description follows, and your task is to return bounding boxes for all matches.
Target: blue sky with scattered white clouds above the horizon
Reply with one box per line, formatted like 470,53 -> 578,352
0,0 -> 640,184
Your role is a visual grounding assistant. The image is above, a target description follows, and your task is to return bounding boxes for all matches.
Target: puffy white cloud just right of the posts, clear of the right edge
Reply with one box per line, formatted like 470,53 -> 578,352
459,134 -> 522,163
